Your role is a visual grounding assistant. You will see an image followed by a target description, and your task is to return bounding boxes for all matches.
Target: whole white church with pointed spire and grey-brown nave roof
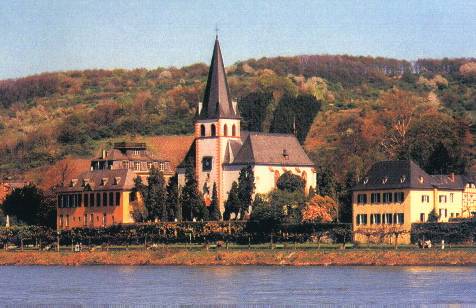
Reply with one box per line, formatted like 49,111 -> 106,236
177,36 -> 316,213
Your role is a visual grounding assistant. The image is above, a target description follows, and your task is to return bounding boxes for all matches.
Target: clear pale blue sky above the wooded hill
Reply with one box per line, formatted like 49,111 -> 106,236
0,0 -> 476,79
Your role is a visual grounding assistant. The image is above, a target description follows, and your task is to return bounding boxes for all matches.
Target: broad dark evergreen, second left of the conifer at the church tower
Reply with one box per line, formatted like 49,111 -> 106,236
144,168 -> 168,221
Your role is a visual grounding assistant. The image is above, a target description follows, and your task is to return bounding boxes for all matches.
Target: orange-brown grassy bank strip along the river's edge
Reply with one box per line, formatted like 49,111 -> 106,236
0,249 -> 476,266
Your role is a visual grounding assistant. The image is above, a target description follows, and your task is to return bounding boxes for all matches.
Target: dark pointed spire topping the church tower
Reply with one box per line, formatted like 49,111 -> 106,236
199,38 -> 240,119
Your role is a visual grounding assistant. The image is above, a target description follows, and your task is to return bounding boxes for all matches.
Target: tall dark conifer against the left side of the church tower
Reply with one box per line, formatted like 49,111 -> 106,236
180,165 -> 208,221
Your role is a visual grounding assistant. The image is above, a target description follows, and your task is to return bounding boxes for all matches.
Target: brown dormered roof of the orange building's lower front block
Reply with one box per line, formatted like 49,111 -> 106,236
58,169 -> 137,192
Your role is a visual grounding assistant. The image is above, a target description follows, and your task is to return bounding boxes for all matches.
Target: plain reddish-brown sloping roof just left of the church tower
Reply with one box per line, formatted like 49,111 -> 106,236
149,135 -> 194,170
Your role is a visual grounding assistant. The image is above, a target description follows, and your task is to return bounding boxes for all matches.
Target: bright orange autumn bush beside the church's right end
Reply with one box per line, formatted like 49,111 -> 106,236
302,195 -> 337,222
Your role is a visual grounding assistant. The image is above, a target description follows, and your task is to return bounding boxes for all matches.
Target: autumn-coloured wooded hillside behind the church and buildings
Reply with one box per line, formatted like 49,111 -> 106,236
0,55 -> 476,198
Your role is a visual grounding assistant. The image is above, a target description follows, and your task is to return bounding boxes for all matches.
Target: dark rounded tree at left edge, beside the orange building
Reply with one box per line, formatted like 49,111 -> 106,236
2,184 -> 56,227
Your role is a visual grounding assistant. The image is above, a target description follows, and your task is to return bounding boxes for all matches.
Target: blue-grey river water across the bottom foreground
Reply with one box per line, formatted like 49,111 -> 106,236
0,266 -> 476,305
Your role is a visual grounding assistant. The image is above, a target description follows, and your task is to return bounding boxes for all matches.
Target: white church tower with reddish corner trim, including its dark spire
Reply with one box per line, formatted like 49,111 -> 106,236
194,36 -> 241,213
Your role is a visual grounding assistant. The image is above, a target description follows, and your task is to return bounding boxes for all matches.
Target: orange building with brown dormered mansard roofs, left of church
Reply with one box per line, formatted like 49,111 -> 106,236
57,142 -> 175,229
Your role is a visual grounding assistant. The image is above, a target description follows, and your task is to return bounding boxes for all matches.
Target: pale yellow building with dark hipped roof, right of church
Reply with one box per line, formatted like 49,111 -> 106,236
352,160 -> 476,243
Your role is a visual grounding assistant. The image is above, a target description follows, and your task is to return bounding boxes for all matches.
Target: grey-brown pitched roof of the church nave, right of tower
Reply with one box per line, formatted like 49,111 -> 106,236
232,132 -> 314,166
